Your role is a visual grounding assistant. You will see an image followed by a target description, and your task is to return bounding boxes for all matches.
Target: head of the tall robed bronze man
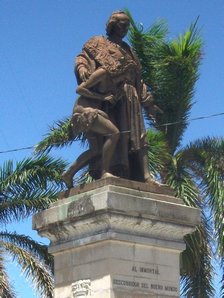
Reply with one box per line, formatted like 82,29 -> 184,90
106,11 -> 130,38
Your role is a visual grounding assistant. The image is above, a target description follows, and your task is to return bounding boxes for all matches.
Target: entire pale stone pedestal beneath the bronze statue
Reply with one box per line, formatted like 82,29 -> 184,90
33,178 -> 199,298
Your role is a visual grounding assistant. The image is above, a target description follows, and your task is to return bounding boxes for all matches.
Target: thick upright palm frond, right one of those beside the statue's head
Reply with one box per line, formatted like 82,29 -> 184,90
153,23 -> 202,152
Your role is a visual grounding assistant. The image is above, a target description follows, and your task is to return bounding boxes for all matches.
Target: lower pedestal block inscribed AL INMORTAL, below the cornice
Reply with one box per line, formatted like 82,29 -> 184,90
51,240 -> 184,298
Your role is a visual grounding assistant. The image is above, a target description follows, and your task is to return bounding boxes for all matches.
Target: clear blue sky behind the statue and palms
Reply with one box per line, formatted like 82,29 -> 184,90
0,0 -> 224,298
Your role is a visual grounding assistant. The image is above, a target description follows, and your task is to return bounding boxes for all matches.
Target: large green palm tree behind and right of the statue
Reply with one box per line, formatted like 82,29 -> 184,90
34,11 -> 224,298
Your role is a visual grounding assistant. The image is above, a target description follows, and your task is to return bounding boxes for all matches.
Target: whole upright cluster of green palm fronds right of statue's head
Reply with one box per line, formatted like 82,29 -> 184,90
130,14 -> 202,153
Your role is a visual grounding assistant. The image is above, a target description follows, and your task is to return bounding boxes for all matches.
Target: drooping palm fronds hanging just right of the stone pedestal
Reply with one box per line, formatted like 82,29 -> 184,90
167,138 -> 224,297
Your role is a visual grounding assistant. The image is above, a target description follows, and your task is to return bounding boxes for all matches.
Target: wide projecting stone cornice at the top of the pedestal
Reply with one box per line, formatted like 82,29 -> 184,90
34,185 -> 198,244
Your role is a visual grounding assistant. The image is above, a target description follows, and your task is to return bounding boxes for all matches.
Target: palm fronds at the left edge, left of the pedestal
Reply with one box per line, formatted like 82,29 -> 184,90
0,155 -> 66,298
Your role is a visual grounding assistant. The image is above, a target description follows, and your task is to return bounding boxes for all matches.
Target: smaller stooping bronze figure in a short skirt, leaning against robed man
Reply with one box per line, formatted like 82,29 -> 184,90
62,68 -> 119,188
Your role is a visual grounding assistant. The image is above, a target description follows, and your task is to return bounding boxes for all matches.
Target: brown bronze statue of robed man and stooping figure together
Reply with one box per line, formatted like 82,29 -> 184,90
63,11 -> 158,188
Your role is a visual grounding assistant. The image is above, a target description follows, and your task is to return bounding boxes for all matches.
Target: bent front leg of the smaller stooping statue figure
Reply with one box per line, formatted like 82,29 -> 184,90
92,115 -> 120,177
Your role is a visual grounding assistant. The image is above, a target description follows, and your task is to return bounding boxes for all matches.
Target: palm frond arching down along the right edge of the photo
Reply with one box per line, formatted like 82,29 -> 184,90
182,138 -> 224,264
